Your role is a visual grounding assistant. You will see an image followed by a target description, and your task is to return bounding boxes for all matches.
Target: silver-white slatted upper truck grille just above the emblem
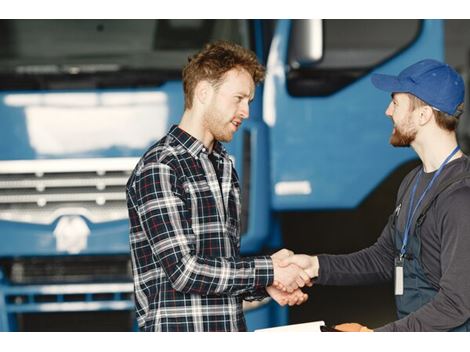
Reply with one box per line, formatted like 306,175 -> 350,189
0,158 -> 138,224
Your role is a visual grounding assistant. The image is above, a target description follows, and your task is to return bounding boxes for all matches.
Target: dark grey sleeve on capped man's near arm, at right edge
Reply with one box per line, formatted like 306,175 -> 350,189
377,187 -> 470,331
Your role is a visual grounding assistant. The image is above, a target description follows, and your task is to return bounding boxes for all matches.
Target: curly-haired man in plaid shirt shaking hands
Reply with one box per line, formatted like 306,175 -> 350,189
127,42 -> 310,331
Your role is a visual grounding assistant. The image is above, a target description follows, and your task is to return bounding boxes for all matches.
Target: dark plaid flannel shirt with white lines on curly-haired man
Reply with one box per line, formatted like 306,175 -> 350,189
127,126 -> 273,331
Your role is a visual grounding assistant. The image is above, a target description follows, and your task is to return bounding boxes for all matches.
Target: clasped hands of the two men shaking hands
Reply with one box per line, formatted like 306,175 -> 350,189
266,249 -> 318,306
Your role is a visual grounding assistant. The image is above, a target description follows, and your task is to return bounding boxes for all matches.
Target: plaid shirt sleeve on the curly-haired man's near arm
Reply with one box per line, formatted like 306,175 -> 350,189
136,163 -> 274,295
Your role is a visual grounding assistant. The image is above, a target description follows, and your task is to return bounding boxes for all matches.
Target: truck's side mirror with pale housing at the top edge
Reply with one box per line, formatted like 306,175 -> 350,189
288,19 -> 323,69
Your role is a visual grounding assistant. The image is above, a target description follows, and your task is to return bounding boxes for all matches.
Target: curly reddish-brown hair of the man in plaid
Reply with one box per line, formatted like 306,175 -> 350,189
183,41 -> 265,110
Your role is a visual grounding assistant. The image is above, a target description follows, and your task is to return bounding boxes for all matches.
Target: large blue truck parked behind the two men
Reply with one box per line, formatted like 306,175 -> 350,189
0,19 -> 444,331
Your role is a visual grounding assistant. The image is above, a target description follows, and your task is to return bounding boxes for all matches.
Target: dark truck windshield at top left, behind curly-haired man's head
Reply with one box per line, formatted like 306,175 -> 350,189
0,19 -> 250,89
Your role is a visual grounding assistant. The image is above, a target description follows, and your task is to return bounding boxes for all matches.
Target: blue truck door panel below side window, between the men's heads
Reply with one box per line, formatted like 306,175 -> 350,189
264,20 -> 443,210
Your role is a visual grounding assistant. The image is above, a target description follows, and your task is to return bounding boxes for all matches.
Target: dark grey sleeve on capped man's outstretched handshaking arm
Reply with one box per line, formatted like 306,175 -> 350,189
315,215 -> 395,286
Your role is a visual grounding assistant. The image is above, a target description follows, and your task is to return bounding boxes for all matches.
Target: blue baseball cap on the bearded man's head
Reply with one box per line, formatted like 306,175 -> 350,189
371,59 -> 465,116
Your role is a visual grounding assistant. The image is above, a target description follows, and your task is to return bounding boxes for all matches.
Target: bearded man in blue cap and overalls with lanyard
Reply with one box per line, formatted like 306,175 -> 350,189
281,59 -> 470,331
